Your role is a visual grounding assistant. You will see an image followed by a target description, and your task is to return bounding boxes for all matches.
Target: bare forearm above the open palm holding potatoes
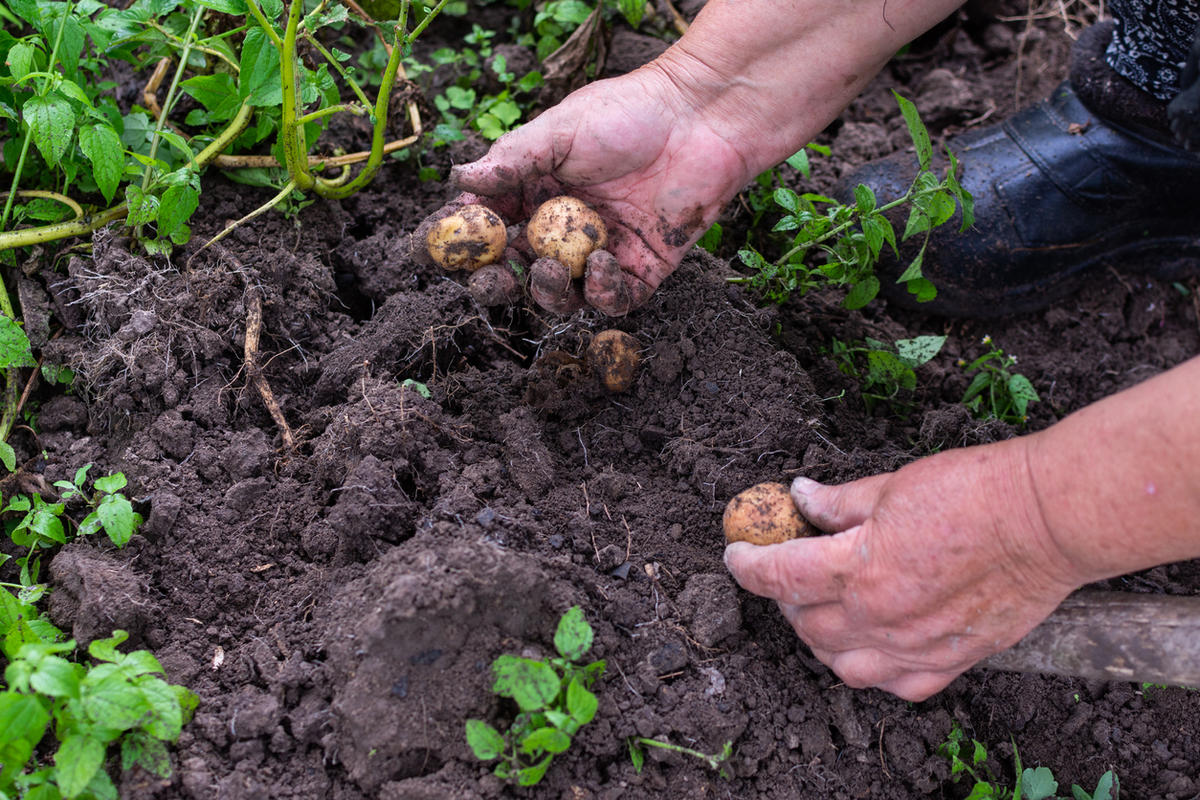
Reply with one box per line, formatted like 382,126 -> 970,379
648,0 -> 961,180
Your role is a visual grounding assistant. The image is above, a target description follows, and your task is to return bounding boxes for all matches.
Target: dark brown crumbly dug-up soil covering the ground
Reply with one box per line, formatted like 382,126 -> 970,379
9,2 -> 1200,800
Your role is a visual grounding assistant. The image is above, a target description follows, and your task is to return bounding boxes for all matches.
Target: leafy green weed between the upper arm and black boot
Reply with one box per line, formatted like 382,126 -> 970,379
732,92 -> 974,308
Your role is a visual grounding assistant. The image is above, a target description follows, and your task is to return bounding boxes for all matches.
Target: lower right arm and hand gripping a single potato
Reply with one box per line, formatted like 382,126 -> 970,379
726,357 -> 1200,700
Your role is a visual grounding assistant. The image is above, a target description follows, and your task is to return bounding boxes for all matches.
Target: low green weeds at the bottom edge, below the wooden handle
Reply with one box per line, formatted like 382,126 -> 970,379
937,722 -> 1121,800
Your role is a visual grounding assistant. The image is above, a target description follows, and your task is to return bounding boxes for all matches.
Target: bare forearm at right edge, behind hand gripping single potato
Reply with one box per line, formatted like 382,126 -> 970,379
1027,357 -> 1200,581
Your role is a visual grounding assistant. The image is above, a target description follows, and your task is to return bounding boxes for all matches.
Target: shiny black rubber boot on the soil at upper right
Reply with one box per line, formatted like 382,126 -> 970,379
838,26 -> 1200,318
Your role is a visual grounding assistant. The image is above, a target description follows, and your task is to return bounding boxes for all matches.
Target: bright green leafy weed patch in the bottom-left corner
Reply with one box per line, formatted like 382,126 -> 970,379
0,467 -> 199,800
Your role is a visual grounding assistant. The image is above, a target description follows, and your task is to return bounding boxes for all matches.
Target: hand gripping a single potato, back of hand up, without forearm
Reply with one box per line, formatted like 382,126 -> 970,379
725,439 -> 1086,700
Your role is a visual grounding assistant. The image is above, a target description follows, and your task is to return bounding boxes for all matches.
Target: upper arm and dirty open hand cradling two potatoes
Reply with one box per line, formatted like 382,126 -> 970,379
452,0 -> 961,314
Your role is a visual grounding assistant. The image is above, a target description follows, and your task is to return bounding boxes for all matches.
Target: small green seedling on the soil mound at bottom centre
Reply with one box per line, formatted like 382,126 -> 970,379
467,606 -> 605,786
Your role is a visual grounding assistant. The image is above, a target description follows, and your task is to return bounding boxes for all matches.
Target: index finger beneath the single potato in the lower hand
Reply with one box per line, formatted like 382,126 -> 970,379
725,534 -> 853,606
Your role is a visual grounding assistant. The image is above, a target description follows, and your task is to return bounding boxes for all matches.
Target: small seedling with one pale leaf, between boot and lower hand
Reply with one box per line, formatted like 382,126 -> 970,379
830,336 -> 946,414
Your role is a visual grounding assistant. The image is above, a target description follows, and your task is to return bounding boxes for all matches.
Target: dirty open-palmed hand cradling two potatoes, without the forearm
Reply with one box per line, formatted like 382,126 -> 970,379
451,65 -> 749,314
